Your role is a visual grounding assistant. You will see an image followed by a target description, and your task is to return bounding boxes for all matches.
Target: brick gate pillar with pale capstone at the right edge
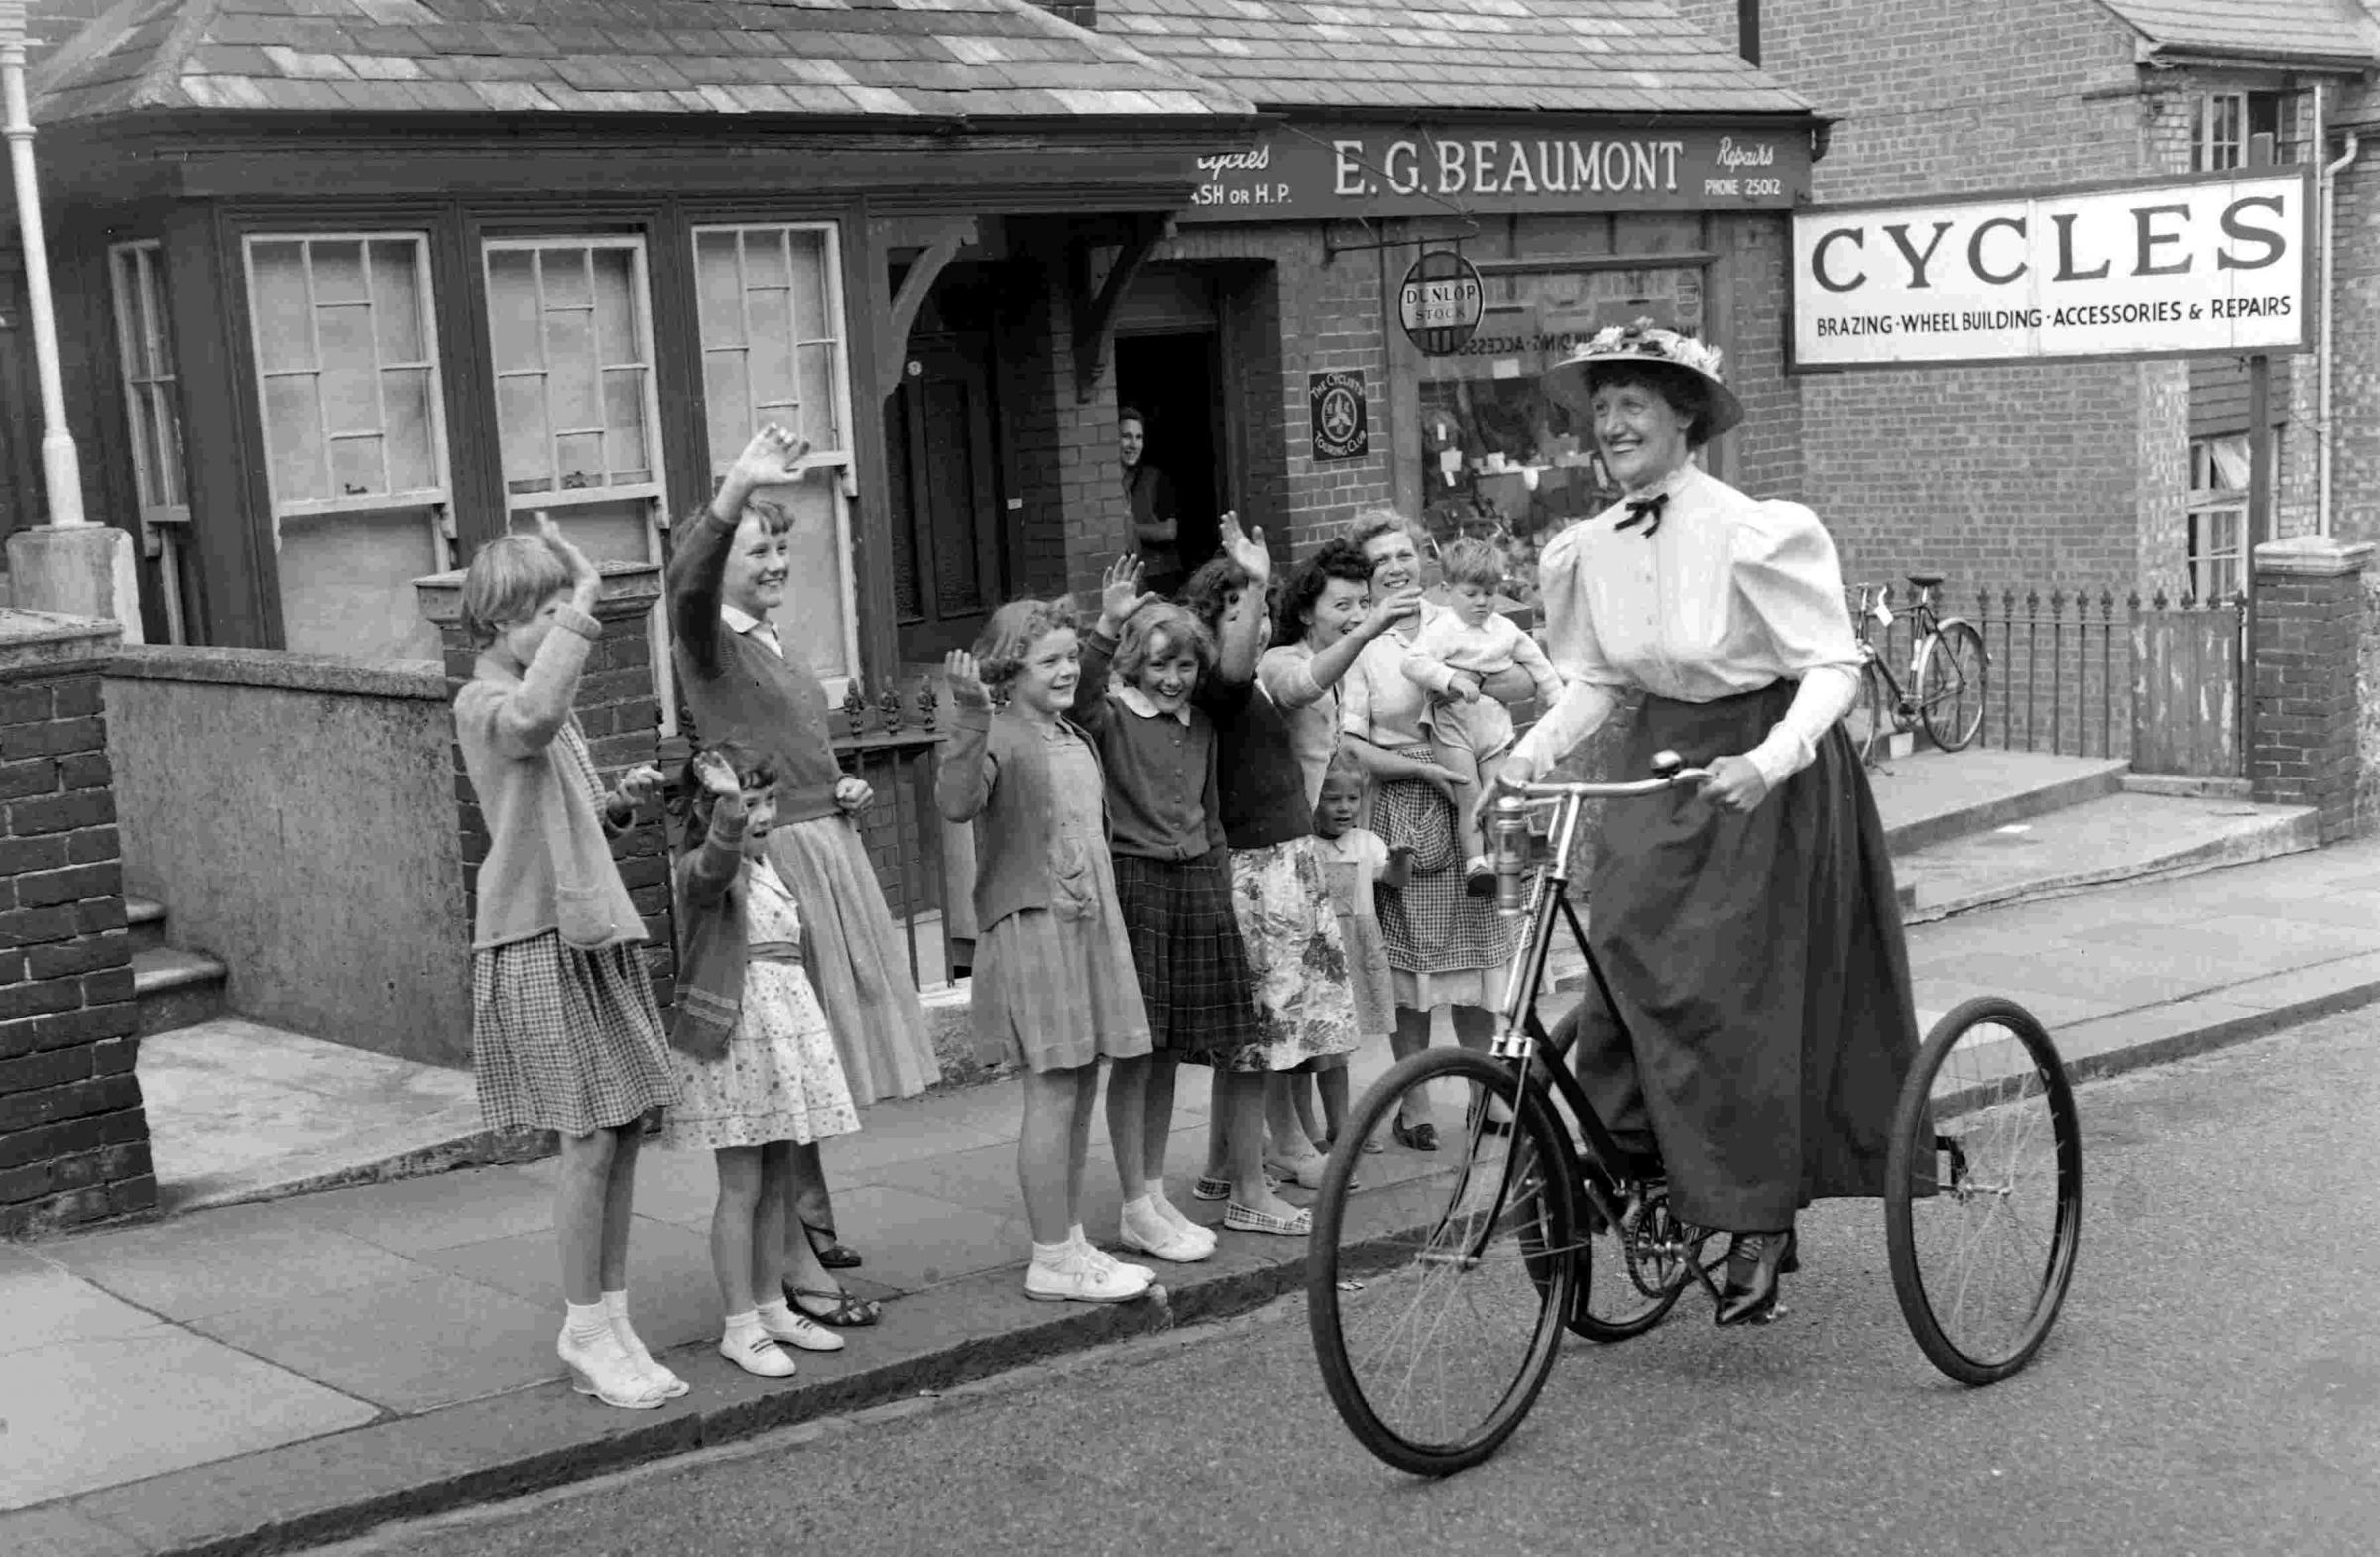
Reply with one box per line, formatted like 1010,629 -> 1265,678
2247,536 -> 2373,843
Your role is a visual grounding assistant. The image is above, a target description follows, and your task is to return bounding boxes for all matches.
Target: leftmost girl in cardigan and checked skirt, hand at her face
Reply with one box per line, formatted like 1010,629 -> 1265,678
454,515 -> 685,1409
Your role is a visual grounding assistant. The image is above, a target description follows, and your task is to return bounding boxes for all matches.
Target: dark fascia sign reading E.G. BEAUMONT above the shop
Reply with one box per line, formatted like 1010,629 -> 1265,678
1178,124 -> 1809,221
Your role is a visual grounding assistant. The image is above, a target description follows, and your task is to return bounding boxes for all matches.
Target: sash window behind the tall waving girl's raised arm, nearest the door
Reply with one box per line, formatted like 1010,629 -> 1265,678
695,224 -> 859,697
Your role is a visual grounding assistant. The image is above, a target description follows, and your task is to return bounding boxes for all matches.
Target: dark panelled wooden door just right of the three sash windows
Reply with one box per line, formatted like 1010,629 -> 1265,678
886,333 -> 1010,664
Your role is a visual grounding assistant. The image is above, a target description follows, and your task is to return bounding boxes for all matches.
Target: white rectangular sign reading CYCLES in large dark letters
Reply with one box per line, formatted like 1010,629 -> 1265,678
1792,169 -> 2314,369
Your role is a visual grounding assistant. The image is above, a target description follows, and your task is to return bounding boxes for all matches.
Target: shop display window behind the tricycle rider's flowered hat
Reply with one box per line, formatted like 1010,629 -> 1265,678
1414,264 -> 1702,605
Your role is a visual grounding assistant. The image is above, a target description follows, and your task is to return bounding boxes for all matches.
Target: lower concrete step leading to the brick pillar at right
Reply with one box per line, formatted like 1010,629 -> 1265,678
1892,790 -> 2320,923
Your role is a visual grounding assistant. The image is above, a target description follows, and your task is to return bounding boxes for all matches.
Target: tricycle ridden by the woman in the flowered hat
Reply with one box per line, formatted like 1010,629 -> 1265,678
1307,753 -> 2082,1476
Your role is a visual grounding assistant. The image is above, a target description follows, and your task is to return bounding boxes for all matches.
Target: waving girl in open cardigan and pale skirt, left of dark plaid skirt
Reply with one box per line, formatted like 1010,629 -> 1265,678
935,600 -> 1166,1302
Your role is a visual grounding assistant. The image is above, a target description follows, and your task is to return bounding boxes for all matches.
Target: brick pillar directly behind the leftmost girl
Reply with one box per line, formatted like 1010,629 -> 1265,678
415,562 -> 678,1012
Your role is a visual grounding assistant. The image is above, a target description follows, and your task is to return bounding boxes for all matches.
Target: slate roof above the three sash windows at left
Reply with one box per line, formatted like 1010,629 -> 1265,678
34,0 -> 1251,124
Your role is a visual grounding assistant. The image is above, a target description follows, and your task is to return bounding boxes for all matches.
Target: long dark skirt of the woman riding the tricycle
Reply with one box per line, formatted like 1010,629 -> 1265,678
1576,681 -> 1918,1231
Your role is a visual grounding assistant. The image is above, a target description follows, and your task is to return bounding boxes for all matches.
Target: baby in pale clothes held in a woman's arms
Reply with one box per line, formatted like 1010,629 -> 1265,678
1404,539 -> 1561,898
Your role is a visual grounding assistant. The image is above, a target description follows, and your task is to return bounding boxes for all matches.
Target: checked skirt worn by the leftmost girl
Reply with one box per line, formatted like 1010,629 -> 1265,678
471,931 -> 678,1136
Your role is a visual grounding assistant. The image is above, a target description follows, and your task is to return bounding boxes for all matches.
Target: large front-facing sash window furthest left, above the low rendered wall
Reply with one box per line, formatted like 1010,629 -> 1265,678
248,233 -> 452,659
